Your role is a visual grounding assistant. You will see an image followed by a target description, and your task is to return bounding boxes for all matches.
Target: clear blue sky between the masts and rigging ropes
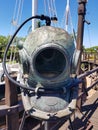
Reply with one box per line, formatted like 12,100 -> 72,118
0,0 -> 98,47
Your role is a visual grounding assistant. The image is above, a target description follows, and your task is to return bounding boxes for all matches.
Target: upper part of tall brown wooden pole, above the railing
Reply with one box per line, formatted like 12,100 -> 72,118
76,0 -> 87,75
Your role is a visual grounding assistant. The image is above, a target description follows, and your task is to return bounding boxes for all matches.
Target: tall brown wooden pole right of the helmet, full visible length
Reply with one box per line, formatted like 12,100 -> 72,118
76,0 -> 87,109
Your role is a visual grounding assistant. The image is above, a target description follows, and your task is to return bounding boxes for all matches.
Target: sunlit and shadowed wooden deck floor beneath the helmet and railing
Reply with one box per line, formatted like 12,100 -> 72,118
23,91 -> 98,130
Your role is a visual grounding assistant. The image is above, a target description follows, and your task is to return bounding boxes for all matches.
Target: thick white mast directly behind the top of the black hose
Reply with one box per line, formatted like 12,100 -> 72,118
32,0 -> 38,31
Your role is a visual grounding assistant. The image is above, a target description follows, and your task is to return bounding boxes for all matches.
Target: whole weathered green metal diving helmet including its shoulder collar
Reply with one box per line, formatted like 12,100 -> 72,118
3,15 -> 79,120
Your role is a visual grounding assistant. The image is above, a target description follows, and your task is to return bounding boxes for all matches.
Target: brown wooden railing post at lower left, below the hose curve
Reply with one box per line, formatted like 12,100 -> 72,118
5,77 -> 19,130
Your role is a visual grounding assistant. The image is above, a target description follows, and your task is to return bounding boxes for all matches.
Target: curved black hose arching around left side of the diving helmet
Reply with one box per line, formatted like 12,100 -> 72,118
3,15 -> 51,91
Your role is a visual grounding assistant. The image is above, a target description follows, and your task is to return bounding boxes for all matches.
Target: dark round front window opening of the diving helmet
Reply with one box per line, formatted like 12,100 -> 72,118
33,47 -> 66,78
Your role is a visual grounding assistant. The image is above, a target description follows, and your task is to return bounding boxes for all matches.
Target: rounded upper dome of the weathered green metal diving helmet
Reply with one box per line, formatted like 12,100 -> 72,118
20,26 -> 75,86
